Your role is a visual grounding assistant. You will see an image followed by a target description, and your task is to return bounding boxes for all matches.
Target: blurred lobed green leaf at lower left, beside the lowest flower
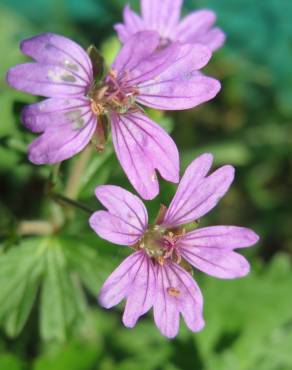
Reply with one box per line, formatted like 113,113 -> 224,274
0,237 -> 116,341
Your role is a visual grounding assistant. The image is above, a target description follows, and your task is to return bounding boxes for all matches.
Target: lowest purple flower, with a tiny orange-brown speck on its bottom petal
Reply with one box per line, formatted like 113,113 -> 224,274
90,154 -> 258,338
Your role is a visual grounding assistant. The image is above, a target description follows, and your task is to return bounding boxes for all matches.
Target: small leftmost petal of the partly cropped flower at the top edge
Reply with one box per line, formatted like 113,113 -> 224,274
114,5 -> 146,43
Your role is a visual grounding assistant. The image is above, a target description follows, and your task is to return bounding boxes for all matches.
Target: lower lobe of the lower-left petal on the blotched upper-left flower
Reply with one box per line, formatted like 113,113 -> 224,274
29,112 -> 96,164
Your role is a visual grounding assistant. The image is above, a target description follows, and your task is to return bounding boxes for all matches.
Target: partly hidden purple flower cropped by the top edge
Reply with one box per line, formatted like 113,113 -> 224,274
115,0 -> 225,51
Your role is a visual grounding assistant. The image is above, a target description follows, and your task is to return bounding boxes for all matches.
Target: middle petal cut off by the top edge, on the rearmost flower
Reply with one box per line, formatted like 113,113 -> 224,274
141,0 -> 182,38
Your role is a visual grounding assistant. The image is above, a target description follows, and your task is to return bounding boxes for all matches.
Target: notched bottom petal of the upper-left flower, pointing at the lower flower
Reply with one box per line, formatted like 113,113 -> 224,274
111,112 -> 179,199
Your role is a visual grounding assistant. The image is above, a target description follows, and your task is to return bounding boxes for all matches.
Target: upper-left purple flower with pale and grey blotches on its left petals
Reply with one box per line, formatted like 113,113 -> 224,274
7,31 -> 220,199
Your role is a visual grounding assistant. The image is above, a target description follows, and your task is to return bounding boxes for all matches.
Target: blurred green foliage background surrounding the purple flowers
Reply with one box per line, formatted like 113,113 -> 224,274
0,0 -> 292,370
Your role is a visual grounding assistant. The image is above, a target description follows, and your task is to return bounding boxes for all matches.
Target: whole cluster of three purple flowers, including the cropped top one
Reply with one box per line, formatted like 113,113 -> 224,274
7,0 -> 258,337
